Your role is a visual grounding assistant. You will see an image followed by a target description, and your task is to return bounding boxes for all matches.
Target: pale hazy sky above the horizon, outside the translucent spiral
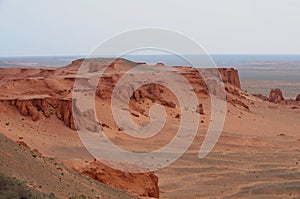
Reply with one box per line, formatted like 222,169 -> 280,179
0,0 -> 300,57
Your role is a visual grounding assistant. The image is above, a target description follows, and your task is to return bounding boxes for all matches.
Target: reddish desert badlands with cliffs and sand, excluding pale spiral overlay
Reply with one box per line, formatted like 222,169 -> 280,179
0,59 -> 300,198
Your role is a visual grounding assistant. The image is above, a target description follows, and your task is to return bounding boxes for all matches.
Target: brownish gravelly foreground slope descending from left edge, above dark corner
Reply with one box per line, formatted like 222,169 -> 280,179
0,135 -> 137,198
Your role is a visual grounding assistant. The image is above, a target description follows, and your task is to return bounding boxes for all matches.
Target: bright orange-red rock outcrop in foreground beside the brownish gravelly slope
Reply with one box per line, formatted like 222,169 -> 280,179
73,160 -> 159,198
